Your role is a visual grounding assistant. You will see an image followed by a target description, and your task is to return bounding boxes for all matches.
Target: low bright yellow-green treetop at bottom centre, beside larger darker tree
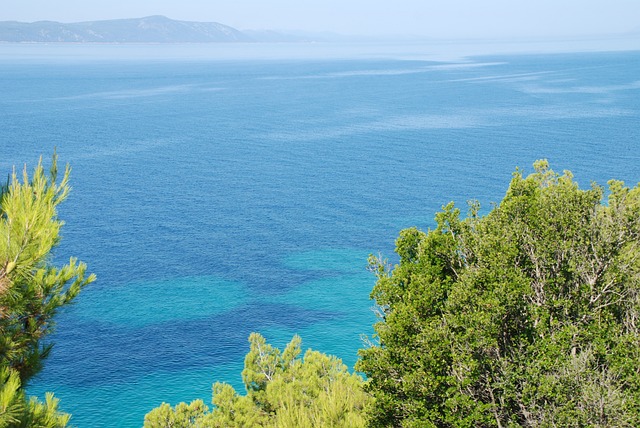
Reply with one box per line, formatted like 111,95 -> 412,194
144,333 -> 370,428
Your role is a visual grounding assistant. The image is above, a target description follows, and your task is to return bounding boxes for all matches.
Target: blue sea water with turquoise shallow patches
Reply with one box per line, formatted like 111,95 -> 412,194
0,46 -> 640,427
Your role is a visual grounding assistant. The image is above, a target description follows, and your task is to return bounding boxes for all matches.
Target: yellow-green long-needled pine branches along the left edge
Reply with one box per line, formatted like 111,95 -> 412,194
0,155 -> 95,427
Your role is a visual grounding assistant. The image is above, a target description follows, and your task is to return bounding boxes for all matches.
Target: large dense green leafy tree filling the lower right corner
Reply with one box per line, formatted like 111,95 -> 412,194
356,161 -> 640,427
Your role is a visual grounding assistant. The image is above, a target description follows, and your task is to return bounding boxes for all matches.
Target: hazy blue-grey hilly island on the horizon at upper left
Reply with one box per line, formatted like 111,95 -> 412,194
0,16 -> 315,43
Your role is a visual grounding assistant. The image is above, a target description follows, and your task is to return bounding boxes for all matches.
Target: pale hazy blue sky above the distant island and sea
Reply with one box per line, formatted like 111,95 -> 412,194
5,0 -> 640,37
